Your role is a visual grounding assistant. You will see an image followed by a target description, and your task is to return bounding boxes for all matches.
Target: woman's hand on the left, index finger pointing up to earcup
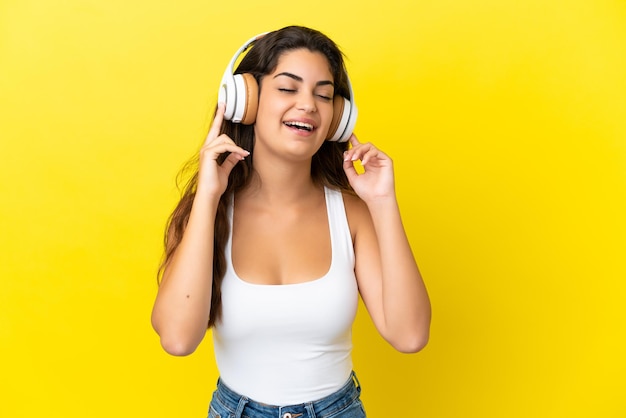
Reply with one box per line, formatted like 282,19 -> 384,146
196,103 -> 250,199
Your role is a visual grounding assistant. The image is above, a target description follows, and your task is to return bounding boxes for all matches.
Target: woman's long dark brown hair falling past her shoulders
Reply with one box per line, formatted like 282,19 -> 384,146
158,26 -> 352,327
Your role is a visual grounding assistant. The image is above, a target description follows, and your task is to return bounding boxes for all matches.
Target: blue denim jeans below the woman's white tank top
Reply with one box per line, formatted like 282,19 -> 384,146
209,372 -> 365,418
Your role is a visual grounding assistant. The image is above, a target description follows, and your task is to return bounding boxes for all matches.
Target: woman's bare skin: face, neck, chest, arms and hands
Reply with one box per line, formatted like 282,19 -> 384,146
152,49 -> 430,355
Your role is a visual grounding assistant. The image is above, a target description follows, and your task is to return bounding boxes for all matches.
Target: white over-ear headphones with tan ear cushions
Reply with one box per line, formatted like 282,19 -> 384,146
217,32 -> 358,142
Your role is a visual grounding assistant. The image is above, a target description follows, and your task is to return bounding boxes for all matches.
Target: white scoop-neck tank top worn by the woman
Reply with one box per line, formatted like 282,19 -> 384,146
213,189 -> 358,406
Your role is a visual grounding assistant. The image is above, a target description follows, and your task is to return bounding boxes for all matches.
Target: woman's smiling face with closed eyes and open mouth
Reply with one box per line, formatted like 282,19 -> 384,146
254,49 -> 335,160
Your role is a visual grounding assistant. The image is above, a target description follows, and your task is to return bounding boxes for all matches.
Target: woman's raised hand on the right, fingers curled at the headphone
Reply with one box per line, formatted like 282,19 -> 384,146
343,134 -> 395,203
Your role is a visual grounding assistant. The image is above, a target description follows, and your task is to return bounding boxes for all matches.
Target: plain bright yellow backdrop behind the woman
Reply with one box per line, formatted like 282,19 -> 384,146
0,0 -> 626,418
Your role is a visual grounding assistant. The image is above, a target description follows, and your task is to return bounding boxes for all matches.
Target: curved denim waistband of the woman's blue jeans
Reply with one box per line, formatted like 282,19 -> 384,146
214,372 -> 361,418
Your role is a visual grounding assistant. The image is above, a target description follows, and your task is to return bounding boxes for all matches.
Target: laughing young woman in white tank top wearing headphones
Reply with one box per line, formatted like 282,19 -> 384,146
152,26 -> 430,418
